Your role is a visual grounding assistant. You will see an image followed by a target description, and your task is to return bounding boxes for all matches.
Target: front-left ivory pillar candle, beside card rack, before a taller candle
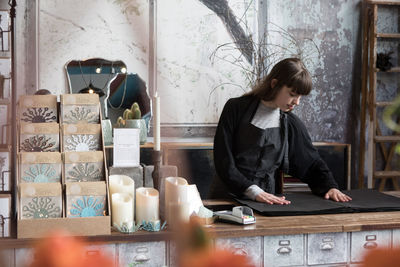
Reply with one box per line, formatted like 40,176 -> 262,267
111,193 -> 134,228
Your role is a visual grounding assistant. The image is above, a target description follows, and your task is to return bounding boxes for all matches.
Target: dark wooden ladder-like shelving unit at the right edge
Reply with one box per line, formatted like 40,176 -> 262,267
358,0 -> 400,191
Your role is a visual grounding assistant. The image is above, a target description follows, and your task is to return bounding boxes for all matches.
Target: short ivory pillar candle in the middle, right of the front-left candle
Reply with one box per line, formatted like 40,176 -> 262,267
136,187 -> 160,224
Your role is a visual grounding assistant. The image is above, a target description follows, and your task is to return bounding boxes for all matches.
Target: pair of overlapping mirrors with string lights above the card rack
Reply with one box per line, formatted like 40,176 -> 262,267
65,58 -> 151,125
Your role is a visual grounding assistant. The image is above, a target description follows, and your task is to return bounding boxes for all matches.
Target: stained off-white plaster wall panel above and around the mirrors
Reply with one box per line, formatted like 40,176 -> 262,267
37,0 -> 149,97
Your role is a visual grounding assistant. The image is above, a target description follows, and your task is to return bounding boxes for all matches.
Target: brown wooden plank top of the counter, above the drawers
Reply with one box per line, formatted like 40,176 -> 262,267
0,201 -> 400,248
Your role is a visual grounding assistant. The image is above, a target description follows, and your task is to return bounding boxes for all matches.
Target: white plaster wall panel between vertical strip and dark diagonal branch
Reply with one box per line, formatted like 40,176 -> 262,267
157,0 -> 255,124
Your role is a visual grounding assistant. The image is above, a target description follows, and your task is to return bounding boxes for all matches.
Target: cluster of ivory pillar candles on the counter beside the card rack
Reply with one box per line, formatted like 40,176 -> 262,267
109,175 -> 203,232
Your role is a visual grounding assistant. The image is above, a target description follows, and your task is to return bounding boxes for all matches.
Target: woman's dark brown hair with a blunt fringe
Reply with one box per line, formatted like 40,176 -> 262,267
246,58 -> 312,101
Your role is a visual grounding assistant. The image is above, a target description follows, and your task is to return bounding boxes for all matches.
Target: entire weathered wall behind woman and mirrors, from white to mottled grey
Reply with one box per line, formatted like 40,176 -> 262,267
18,0 -> 361,142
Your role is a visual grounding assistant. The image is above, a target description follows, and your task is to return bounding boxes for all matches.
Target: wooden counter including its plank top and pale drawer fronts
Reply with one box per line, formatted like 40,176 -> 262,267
0,196 -> 400,267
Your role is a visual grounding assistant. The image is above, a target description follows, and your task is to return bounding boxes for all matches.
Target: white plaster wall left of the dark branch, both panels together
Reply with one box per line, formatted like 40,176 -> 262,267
26,0 -> 255,125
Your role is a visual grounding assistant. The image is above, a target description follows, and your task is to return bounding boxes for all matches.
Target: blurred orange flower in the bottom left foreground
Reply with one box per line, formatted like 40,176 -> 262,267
30,232 -> 114,267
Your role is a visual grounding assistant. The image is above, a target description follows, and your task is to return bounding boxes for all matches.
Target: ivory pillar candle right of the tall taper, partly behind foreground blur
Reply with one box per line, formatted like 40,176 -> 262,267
164,177 -> 188,224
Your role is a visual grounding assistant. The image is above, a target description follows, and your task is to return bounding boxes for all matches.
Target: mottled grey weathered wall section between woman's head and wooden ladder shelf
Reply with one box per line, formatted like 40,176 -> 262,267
265,0 -> 361,143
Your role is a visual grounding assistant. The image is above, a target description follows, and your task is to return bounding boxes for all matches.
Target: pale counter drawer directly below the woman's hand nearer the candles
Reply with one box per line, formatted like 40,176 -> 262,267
264,235 -> 304,267
